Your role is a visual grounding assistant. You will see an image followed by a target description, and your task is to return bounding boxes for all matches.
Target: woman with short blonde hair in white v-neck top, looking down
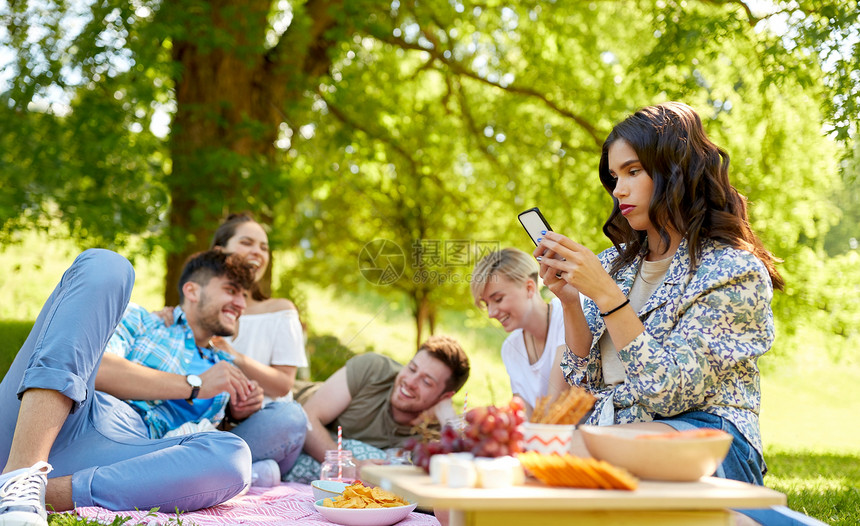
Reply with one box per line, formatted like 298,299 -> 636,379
471,248 -> 566,411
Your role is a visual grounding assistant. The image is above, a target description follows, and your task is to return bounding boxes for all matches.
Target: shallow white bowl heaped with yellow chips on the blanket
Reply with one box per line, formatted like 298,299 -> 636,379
314,482 -> 417,526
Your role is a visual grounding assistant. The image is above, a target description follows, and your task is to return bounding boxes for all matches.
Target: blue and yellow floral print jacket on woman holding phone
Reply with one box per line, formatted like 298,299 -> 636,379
561,239 -> 774,453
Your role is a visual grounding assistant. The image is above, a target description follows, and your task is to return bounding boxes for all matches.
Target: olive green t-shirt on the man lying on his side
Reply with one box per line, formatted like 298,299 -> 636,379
328,353 -> 414,449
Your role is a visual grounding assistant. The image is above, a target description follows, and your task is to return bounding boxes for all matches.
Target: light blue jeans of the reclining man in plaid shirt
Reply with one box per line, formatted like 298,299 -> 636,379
0,249 -> 251,512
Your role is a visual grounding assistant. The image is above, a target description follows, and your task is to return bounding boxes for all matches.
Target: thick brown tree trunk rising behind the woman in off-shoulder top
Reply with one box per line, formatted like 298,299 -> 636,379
165,0 -> 339,305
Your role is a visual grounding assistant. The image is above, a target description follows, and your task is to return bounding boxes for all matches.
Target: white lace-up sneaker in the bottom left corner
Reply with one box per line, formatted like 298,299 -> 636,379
0,462 -> 52,526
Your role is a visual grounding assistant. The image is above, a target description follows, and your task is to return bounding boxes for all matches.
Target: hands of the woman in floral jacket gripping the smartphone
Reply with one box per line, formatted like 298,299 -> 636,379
534,232 -> 623,307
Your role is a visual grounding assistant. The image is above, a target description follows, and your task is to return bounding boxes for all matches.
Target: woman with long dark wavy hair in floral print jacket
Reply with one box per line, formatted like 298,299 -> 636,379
535,102 -> 783,484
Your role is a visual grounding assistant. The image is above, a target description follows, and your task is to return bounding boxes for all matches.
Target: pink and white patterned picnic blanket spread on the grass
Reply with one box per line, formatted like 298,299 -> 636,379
75,482 -> 439,526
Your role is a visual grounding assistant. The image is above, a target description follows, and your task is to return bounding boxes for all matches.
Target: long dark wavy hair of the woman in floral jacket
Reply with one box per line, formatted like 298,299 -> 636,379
599,102 -> 785,290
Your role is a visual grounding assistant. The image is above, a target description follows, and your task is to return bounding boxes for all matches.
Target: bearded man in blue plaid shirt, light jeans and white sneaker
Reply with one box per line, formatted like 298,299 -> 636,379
0,249 -> 307,526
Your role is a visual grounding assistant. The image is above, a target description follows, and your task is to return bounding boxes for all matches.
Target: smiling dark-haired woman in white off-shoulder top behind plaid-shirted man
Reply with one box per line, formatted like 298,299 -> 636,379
211,213 -> 308,403
